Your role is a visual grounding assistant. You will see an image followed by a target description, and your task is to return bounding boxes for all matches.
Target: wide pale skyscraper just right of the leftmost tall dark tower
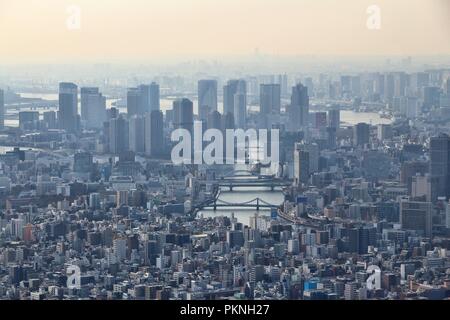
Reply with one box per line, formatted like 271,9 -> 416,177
80,87 -> 106,129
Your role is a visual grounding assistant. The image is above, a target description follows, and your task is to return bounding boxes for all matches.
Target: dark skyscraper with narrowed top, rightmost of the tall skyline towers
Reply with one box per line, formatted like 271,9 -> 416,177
288,83 -> 309,131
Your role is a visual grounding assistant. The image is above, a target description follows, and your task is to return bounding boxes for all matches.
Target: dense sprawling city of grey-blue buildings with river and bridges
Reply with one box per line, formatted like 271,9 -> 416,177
0,58 -> 450,300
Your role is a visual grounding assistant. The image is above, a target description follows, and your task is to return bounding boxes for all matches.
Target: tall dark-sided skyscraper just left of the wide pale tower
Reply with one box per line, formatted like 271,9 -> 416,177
58,82 -> 78,133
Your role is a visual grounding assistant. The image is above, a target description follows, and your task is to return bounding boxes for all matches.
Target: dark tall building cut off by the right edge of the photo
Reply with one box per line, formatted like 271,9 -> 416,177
430,134 -> 450,200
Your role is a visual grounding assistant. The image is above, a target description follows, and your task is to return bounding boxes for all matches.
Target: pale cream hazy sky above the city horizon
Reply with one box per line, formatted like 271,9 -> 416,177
0,0 -> 450,64
